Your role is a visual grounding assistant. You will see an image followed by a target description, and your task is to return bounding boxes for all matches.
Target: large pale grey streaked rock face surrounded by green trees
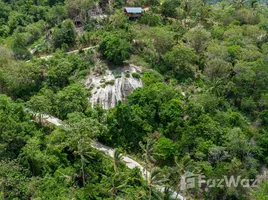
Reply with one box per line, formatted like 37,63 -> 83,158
85,65 -> 143,109
